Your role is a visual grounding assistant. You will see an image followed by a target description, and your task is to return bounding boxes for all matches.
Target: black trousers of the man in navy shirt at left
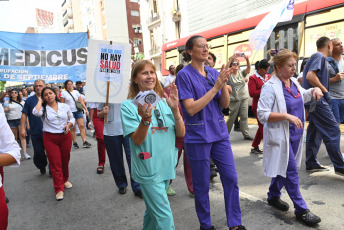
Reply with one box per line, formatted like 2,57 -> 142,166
31,135 -> 48,169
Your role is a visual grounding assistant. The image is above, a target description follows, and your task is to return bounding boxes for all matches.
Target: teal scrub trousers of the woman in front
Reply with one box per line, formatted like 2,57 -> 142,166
140,180 -> 174,230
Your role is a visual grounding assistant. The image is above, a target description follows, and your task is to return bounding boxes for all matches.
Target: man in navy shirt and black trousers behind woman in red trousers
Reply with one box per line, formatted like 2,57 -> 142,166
20,79 -> 48,174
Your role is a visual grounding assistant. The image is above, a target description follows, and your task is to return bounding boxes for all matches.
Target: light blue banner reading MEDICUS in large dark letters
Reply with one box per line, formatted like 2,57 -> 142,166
0,31 -> 88,83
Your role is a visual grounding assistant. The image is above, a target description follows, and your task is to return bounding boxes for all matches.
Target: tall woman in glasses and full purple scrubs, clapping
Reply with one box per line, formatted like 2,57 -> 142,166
176,35 -> 246,230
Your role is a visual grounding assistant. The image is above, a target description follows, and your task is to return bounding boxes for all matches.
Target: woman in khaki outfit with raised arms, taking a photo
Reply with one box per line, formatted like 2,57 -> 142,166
227,54 -> 253,140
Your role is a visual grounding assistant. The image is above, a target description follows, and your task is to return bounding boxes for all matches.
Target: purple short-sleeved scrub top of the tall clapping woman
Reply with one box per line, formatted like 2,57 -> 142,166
176,65 -> 229,143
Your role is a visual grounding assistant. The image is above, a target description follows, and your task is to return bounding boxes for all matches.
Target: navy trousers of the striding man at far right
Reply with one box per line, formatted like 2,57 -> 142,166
306,97 -> 344,170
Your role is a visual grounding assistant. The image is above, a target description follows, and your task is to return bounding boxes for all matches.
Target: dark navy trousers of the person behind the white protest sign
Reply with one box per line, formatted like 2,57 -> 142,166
104,135 -> 141,192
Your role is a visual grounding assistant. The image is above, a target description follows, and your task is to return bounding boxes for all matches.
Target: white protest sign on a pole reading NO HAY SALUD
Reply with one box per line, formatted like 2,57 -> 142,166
85,39 -> 131,103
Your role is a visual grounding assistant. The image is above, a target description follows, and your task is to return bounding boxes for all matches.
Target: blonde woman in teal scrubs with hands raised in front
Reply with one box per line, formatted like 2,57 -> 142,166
121,60 -> 185,230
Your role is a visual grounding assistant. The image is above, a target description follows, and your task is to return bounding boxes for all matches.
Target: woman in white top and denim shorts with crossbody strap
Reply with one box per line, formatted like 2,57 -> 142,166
60,80 -> 91,149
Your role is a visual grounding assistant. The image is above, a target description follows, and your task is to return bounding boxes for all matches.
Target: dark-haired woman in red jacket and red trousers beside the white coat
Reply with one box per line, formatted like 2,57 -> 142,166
248,59 -> 270,154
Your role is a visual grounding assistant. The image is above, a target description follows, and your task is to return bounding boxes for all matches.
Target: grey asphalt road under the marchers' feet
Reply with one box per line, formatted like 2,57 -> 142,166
4,125 -> 344,230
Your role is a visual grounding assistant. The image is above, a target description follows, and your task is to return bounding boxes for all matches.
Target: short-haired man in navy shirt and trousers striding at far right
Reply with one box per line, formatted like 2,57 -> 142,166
303,37 -> 344,176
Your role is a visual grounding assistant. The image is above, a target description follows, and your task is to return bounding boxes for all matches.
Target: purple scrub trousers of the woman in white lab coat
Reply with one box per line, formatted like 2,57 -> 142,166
268,140 -> 308,215
